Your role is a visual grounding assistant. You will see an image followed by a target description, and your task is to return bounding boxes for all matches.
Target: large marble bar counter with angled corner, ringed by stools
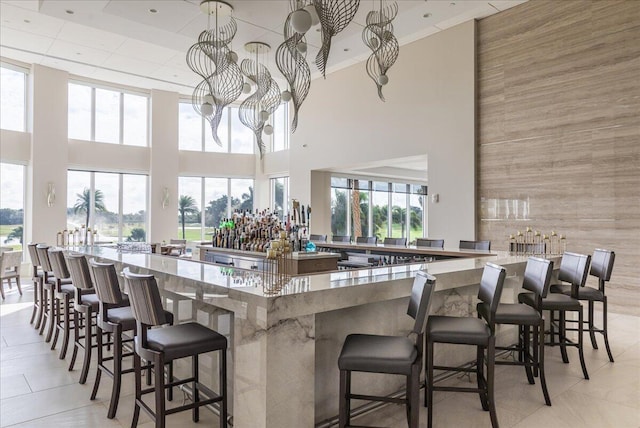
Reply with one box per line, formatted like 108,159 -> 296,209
70,247 -> 556,428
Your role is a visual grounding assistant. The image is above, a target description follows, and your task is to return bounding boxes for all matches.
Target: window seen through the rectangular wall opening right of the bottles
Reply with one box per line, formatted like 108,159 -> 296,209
331,177 -> 427,242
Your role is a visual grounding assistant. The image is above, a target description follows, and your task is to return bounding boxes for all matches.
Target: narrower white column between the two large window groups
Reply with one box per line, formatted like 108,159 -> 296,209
149,89 -> 180,242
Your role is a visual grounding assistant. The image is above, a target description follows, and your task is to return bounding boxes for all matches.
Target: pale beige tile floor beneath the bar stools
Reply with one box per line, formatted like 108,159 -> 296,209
0,284 -> 640,428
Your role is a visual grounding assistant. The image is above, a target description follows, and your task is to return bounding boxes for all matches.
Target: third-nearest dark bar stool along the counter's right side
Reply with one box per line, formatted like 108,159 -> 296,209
476,257 -> 553,406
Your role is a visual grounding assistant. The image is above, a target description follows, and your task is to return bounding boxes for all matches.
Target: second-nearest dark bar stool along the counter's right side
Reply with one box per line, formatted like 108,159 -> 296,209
424,263 -> 506,428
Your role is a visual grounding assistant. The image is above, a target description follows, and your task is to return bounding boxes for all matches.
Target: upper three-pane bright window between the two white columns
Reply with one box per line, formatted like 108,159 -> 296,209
69,82 -> 149,146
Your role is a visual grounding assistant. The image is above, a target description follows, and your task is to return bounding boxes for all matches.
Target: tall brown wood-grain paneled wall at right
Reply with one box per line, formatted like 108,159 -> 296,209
477,0 -> 640,315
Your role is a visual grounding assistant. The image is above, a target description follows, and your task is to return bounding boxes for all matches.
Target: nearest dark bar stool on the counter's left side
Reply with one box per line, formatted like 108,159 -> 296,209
124,268 -> 228,428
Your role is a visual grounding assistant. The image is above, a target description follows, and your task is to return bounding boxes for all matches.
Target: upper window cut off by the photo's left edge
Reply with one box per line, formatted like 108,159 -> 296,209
0,65 -> 27,132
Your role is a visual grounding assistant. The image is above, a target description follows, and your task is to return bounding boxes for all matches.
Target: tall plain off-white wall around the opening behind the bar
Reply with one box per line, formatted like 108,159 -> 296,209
278,21 -> 475,243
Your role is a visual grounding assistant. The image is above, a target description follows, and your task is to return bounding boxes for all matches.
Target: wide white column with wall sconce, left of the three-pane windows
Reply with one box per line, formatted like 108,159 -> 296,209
25,64 -> 69,244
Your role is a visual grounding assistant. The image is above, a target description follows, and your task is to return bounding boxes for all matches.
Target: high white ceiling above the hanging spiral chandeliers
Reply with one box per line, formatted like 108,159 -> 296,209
0,0 -> 526,95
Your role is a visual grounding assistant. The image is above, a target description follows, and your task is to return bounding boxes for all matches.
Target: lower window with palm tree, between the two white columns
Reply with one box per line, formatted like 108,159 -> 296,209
67,171 -> 147,242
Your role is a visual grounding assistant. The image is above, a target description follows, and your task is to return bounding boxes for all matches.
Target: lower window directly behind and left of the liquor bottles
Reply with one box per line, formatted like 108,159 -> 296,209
178,177 -> 254,241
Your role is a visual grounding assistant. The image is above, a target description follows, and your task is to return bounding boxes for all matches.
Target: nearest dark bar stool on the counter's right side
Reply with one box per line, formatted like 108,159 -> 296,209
338,271 -> 436,428
